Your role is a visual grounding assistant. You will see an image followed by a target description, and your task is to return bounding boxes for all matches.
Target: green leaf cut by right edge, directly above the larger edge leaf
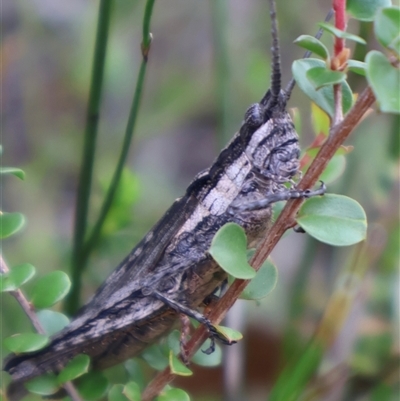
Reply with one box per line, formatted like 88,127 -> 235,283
374,7 -> 400,55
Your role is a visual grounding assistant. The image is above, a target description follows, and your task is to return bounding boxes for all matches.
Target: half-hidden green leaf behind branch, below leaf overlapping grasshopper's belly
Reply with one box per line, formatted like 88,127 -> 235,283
240,259 -> 278,300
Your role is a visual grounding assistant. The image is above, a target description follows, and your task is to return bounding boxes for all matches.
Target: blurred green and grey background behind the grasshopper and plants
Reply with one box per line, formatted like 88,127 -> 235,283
1,0 -> 399,400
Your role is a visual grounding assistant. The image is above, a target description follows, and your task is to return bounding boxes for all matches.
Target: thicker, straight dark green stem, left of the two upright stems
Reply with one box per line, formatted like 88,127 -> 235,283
65,0 -> 112,313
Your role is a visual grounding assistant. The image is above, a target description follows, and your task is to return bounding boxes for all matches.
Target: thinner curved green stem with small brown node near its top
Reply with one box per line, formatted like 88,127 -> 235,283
82,0 -> 155,288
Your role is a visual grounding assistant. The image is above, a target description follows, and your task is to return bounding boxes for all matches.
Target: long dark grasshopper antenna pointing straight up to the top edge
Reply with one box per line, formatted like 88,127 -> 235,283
267,0 -> 281,108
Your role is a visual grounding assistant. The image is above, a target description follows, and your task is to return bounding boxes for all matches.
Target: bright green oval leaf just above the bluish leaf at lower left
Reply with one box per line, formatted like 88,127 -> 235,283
31,270 -> 71,309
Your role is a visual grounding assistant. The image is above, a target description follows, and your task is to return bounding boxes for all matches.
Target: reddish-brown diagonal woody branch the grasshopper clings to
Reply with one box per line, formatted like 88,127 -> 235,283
142,87 -> 375,401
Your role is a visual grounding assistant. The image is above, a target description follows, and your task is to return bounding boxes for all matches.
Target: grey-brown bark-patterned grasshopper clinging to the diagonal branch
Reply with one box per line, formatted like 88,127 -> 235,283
4,1 -> 324,388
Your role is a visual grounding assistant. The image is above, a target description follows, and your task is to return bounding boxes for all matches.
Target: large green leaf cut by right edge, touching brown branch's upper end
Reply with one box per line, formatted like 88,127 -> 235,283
366,50 -> 400,114
